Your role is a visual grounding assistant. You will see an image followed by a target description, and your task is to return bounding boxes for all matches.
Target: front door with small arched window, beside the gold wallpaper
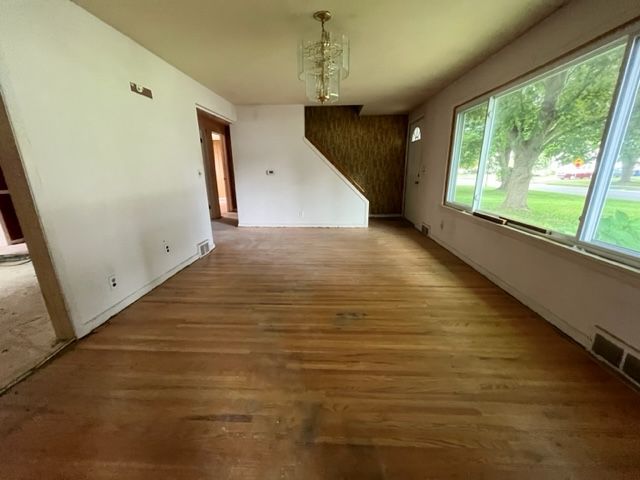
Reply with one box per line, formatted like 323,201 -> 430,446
404,118 -> 425,225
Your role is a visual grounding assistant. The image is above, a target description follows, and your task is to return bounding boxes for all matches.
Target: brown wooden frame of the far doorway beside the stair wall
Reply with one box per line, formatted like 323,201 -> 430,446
196,107 -> 238,219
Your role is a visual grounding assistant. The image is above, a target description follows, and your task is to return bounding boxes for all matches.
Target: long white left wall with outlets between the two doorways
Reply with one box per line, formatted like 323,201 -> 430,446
0,0 -> 235,336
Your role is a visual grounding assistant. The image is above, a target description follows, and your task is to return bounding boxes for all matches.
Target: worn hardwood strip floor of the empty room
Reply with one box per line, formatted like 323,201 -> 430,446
0,221 -> 640,480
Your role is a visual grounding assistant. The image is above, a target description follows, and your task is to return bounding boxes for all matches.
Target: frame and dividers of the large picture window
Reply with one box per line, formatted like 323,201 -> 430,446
442,18 -> 640,269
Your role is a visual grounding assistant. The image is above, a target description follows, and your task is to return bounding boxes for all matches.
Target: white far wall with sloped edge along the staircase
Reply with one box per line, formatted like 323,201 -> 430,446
231,105 -> 369,227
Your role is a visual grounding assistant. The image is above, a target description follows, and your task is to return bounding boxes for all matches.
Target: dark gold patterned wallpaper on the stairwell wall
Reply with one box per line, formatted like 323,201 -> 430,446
305,106 -> 408,214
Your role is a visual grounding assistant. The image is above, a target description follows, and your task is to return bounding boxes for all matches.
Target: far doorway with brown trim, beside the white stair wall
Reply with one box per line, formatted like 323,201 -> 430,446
197,109 -> 238,226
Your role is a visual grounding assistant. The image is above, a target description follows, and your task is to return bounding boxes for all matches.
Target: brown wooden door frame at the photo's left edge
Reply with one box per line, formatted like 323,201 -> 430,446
0,93 -> 76,340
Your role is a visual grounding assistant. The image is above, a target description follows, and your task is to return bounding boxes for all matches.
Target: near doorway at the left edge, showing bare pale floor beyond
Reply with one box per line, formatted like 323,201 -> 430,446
0,95 -> 75,392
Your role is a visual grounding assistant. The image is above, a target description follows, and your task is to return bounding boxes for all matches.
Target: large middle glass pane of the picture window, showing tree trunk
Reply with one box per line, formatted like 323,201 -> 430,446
479,45 -> 625,236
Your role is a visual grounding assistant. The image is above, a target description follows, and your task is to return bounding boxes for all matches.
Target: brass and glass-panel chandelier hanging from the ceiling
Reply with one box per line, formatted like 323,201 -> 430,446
298,10 -> 349,104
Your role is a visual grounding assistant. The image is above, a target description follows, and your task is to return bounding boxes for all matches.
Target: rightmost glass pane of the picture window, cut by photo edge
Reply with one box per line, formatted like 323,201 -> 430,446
595,77 -> 640,253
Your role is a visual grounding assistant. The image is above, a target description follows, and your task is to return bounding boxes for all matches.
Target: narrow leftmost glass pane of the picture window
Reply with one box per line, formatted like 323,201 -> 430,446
449,102 -> 488,206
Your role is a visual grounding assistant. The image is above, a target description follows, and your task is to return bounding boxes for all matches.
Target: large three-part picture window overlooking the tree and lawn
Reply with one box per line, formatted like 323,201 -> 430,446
446,33 -> 640,261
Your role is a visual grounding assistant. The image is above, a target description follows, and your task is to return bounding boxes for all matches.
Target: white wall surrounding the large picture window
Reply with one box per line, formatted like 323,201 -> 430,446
404,0 -> 640,347
